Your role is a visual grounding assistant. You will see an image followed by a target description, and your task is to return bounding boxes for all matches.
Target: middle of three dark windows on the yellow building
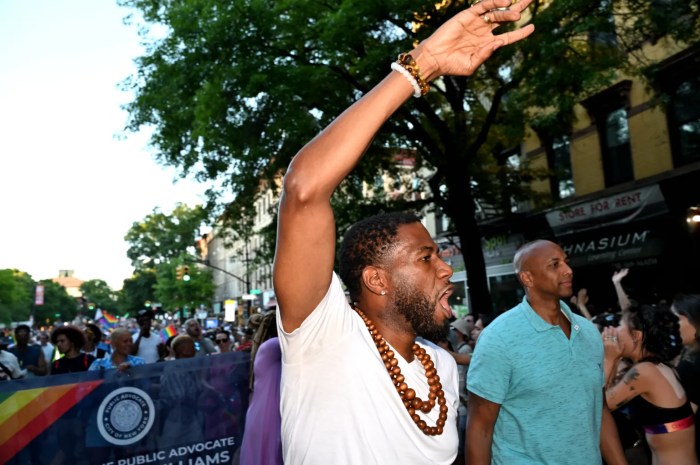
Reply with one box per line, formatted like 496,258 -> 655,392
582,81 -> 634,187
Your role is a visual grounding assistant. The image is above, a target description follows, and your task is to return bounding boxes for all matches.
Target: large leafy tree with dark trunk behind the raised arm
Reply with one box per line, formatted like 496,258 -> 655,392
120,0 -> 700,311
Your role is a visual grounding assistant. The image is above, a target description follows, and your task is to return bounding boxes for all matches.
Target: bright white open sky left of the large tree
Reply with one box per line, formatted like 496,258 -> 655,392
0,0 -> 205,288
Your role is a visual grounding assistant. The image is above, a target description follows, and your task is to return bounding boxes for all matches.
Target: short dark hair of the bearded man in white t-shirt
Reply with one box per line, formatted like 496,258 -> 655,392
338,212 -> 420,301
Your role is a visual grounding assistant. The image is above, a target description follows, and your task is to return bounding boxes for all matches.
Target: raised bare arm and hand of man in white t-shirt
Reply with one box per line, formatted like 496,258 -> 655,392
273,0 -> 534,331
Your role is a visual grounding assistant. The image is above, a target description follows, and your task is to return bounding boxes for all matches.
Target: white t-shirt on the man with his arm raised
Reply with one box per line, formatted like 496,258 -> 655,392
277,273 -> 458,465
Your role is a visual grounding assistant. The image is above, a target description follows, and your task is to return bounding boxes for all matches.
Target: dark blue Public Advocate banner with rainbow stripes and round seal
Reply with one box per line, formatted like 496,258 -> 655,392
0,352 -> 250,465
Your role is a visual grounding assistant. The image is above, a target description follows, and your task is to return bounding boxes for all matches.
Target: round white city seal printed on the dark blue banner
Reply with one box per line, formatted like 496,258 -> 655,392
97,387 -> 155,446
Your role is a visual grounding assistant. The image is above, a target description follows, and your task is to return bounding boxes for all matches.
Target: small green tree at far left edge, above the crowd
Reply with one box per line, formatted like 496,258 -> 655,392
0,269 -> 35,324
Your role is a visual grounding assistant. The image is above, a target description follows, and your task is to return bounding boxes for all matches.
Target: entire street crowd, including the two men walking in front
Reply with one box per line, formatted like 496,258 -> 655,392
0,0 -> 700,465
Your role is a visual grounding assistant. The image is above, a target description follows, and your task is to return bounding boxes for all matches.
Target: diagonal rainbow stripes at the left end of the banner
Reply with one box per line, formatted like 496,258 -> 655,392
0,380 -> 102,463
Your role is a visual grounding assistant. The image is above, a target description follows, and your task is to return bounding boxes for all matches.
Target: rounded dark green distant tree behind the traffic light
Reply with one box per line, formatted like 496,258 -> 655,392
154,256 -> 214,313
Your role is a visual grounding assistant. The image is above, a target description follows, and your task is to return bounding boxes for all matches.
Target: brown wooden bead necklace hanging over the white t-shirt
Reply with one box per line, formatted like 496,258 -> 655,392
355,307 -> 447,436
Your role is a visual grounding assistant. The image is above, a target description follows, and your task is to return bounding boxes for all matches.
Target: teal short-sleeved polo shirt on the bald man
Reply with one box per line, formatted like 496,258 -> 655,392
467,298 -> 604,465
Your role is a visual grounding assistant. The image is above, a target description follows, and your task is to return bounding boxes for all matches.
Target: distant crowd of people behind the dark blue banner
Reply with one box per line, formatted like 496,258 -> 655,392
0,309 -> 262,380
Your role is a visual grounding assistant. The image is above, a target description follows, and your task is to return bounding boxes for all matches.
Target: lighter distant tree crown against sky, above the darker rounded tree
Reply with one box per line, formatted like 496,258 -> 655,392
124,203 -> 207,270
